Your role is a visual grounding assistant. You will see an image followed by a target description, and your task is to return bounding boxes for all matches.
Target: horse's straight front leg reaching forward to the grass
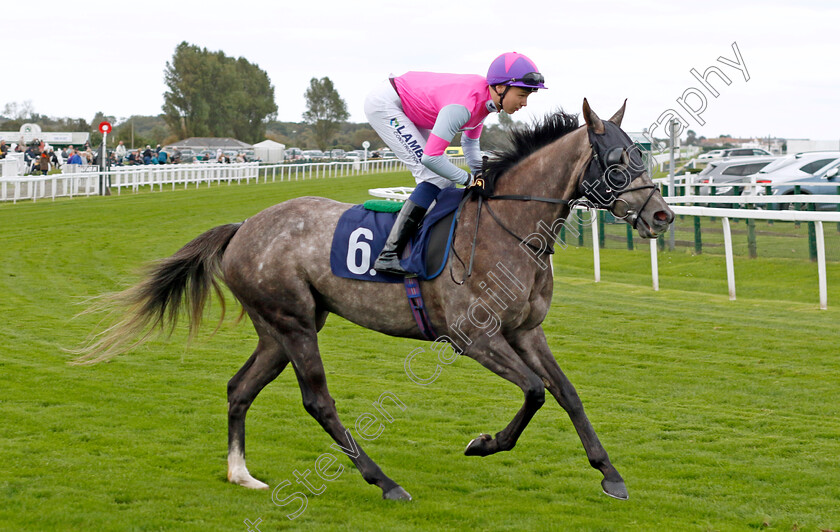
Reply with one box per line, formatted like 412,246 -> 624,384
509,327 -> 628,500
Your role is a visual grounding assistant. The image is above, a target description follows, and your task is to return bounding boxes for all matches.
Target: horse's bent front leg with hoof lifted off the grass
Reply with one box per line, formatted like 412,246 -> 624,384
456,334 -> 545,456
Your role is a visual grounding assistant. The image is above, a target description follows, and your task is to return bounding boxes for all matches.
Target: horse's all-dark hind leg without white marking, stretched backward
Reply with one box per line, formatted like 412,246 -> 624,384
283,330 -> 411,500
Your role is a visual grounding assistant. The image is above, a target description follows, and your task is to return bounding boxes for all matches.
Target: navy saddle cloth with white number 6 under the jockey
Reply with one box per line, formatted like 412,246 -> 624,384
330,187 -> 464,283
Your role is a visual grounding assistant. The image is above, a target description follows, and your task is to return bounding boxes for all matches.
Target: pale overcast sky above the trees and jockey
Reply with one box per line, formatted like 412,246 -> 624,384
6,0 -> 840,139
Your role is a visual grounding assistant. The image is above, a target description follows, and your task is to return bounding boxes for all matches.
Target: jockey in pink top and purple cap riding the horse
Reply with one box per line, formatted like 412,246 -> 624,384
365,52 -> 546,275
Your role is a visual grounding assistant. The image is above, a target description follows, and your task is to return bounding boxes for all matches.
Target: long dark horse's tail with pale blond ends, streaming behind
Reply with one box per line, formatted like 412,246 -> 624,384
71,223 -> 242,365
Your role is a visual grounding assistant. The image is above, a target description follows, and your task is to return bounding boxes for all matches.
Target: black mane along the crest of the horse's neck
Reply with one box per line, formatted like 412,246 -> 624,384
483,110 -> 578,190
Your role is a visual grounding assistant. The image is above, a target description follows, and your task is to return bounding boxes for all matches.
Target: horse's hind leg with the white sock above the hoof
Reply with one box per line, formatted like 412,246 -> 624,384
227,333 -> 289,489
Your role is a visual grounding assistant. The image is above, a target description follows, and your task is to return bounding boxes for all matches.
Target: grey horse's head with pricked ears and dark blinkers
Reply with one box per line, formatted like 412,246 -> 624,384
577,98 -> 674,238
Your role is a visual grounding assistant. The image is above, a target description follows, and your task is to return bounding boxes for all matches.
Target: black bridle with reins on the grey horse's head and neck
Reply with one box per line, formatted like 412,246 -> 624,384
449,121 -> 659,284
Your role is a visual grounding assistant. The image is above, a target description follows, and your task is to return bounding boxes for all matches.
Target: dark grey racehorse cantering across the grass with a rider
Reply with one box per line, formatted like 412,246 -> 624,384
75,100 -> 674,499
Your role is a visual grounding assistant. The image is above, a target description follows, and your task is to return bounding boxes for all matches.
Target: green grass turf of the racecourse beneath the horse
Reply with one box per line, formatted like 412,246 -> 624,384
0,174 -> 840,531
